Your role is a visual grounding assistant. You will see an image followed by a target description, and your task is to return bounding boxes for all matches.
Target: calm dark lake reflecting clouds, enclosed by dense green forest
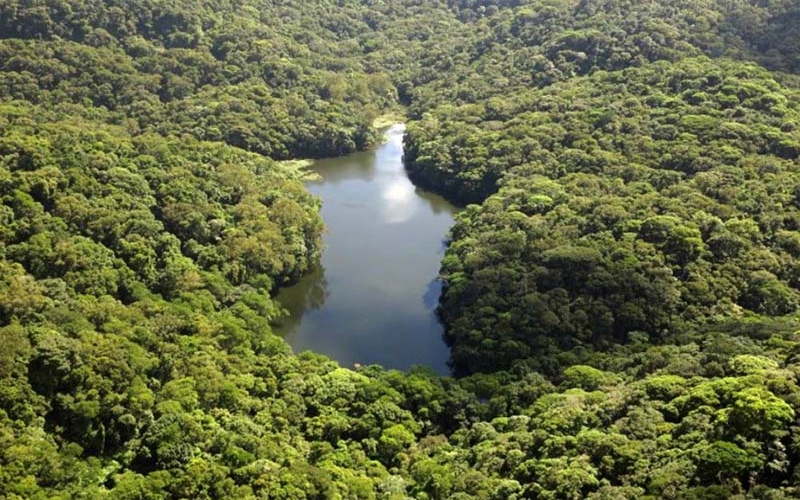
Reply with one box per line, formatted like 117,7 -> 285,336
277,125 -> 456,374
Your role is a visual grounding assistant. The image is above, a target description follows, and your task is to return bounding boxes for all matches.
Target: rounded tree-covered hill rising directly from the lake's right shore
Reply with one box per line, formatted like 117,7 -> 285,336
428,58 -> 800,374
